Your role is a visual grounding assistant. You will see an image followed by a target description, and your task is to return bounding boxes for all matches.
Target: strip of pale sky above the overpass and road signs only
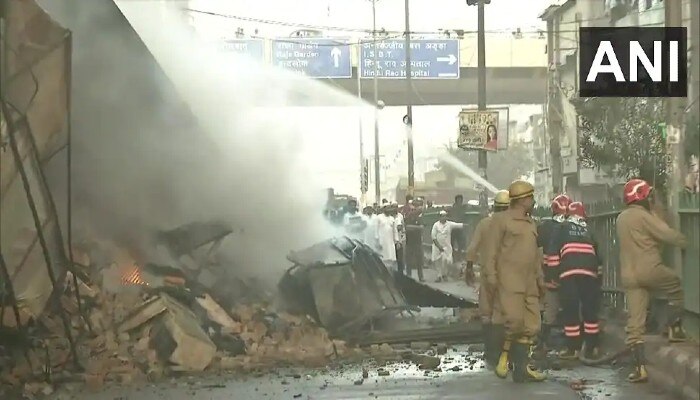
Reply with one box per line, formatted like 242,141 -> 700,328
190,0 -> 556,36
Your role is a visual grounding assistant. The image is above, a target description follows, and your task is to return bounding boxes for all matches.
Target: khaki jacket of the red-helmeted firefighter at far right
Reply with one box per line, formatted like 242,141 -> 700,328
617,205 -> 687,287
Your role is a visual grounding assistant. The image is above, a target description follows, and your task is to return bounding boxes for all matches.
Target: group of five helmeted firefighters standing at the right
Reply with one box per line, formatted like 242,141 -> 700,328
467,179 -> 686,383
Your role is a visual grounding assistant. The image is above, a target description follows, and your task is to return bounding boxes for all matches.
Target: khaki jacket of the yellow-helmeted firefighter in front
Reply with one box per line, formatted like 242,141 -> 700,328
483,210 -> 542,293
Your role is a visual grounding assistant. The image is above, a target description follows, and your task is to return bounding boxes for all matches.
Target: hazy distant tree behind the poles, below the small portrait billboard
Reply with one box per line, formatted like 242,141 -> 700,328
438,142 -> 534,189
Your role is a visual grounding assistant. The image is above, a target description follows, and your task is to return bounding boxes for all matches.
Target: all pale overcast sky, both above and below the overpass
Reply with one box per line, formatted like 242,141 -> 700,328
182,0 -> 556,194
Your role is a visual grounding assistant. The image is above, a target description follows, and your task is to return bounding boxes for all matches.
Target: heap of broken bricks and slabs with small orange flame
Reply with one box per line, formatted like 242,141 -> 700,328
0,222 -> 357,398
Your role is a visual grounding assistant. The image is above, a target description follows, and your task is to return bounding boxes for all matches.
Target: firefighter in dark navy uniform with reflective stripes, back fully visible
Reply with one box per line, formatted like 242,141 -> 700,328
549,201 -> 602,360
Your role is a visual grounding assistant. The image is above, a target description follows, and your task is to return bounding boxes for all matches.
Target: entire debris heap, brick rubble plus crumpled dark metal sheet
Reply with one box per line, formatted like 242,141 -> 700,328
0,227 -> 482,398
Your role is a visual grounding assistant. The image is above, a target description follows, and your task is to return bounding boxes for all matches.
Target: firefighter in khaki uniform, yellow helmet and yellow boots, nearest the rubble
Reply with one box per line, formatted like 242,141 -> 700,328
484,181 -> 546,382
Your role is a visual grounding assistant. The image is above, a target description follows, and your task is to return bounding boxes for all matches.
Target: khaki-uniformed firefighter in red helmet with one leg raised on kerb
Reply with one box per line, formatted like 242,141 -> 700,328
617,179 -> 687,382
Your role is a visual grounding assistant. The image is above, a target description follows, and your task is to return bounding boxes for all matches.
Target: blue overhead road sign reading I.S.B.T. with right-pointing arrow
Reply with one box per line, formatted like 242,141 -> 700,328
360,39 -> 459,79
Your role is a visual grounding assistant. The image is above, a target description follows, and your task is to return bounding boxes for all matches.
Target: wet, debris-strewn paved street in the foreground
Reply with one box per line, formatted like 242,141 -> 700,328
57,352 -> 670,400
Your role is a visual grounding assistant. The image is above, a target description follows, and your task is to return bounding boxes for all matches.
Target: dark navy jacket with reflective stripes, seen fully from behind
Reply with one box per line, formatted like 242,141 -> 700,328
549,217 -> 603,279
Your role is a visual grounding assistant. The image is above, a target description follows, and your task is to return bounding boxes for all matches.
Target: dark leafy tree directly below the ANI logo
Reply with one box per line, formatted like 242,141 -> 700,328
575,97 -> 668,191
